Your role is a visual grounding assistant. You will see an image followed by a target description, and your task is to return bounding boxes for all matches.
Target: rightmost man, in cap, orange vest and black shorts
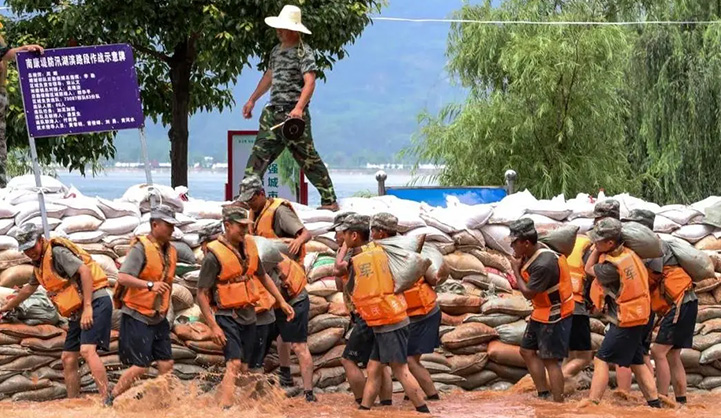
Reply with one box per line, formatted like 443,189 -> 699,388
624,209 -> 698,404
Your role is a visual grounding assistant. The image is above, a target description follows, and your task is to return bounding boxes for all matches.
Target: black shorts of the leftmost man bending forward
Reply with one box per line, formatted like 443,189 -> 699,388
63,296 -> 113,353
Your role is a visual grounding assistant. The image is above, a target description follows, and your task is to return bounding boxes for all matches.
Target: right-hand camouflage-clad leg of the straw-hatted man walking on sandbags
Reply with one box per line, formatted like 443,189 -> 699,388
287,109 -> 336,206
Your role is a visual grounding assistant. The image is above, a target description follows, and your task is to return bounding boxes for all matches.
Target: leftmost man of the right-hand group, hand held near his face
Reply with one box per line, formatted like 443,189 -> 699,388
510,219 -> 574,402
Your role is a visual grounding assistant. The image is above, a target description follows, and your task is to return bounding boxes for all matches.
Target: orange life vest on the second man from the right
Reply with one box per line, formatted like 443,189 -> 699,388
591,247 -> 651,328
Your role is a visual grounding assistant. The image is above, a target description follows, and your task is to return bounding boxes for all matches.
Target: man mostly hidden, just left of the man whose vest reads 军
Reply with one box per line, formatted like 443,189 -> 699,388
330,212 -> 393,406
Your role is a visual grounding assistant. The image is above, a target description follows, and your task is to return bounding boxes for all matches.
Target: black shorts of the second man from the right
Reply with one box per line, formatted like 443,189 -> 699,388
596,324 -> 647,367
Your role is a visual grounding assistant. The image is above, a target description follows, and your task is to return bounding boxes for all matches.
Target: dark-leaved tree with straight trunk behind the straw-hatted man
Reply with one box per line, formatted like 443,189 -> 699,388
8,0 -> 382,186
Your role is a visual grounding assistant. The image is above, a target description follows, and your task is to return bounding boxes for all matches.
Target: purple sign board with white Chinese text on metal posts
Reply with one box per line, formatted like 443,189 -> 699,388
17,44 -> 145,138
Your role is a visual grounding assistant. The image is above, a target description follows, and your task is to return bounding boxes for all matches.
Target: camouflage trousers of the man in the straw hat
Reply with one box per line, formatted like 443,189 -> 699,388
245,106 -> 336,205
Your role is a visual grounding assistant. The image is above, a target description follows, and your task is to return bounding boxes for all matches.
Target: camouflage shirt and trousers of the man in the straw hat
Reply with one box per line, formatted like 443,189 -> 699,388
245,43 -> 336,205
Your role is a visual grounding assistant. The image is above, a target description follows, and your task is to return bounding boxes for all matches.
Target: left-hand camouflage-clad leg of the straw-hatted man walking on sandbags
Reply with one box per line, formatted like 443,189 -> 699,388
245,107 -> 285,178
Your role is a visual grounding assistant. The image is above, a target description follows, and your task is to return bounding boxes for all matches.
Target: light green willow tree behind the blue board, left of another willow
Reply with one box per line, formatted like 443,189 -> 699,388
406,0 -> 639,198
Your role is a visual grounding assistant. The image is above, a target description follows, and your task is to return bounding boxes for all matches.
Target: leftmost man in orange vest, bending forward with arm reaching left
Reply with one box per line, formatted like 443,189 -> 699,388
0,224 -> 113,399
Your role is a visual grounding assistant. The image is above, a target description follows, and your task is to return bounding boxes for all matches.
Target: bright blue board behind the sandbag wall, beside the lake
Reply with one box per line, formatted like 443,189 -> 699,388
386,187 -> 506,207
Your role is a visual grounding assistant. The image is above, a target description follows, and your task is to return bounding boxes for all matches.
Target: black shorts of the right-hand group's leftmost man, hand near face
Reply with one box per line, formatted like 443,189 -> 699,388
521,316 -> 573,360
